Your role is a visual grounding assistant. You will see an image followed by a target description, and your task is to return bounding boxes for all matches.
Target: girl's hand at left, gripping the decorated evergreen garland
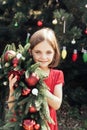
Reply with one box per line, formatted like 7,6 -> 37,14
9,74 -> 17,92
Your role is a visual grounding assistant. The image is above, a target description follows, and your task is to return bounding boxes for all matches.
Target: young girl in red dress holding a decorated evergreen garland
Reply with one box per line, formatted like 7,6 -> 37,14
8,28 -> 64,130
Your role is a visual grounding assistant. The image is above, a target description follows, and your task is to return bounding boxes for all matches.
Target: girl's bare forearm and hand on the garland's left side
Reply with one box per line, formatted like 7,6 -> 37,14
8,74 -> 17,109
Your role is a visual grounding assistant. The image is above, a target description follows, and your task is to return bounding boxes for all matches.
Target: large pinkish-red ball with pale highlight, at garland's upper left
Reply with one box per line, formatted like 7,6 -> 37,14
4,50 -> 16,62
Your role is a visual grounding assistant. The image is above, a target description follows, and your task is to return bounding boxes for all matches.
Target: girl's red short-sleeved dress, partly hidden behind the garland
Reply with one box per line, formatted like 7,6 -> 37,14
44,69 -> 64,130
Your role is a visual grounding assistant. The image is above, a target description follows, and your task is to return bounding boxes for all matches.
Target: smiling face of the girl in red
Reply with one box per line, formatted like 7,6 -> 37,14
32,41 -> 54,70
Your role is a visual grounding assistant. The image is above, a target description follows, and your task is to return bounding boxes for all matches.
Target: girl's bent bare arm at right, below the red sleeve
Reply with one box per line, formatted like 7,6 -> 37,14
47,83 -> 63,110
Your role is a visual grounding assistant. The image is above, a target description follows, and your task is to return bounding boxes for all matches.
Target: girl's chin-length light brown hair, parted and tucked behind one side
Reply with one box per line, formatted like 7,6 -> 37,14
30,28 -> 60,68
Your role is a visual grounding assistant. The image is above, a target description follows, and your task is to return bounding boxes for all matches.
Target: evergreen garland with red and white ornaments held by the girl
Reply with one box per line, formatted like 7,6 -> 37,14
0,39 -> 53,130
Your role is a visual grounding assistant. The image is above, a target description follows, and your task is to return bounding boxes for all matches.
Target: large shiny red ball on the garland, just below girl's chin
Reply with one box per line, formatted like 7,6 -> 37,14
25,73 -> 39,87
